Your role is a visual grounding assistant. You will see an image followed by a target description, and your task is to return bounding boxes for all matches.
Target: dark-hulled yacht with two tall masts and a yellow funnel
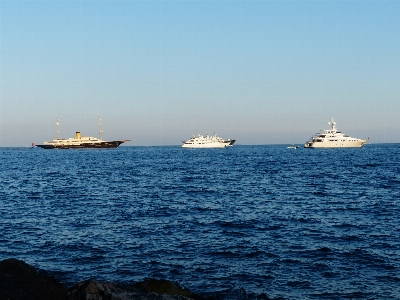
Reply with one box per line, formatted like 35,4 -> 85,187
36,118 -> 129,149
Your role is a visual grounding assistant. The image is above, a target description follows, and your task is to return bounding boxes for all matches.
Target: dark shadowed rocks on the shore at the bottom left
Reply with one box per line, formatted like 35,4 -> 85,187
0,258 -> 211,300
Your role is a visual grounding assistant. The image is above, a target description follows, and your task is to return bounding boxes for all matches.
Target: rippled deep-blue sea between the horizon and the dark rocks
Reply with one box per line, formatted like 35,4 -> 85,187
0,144 -> 400,299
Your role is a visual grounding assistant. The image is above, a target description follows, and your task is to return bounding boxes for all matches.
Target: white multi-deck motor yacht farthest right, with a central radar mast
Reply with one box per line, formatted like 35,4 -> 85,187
304,119 -> 368,148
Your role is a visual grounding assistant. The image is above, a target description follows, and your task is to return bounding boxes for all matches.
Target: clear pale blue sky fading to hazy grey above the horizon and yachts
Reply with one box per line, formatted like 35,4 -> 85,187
0,0 -> 400,147
